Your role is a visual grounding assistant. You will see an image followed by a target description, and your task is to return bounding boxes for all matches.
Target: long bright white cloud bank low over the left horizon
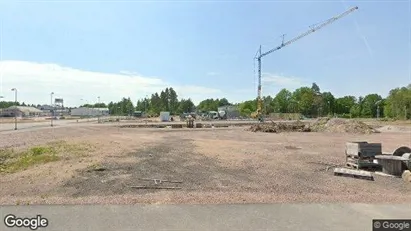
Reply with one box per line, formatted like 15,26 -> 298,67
0,61 -> 221,106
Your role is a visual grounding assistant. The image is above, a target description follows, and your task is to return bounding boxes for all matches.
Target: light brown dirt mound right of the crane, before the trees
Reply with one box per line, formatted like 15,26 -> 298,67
310,118 -> 378,134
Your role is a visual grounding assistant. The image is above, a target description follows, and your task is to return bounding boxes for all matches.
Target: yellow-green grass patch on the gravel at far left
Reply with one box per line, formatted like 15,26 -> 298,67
0,141 -> 94,173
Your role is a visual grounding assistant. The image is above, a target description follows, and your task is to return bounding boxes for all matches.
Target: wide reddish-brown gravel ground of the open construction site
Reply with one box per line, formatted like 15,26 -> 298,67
0,120 -> 411,205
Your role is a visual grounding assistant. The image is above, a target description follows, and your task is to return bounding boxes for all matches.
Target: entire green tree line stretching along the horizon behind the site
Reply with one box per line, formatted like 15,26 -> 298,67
0,83 -> 411,119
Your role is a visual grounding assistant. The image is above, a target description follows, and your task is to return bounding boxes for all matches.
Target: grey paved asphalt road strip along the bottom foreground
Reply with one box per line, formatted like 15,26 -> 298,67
0,204 -> 411,231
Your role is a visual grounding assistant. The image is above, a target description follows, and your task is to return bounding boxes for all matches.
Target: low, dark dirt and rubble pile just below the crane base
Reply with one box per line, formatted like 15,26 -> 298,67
246,121 -> 311,133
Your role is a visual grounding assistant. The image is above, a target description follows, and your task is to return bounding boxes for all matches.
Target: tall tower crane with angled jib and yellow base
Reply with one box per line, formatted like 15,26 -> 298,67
251,7 -> 358,122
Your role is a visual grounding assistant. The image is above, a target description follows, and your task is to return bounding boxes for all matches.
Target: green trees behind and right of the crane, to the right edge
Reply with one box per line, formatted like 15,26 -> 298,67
230,83 -> 411,119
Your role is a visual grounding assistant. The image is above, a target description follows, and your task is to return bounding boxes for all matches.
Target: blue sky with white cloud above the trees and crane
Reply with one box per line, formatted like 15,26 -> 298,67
0,0 -> 411,105
